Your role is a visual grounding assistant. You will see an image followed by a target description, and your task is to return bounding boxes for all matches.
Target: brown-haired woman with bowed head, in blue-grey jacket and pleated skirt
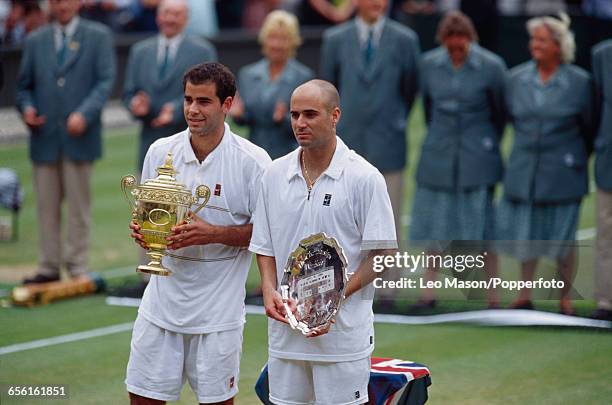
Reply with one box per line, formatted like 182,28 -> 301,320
410,11 -> 506,310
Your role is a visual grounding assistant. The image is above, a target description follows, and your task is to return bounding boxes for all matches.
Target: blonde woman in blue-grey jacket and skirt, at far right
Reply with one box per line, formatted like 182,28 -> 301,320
496,14 -> 594,314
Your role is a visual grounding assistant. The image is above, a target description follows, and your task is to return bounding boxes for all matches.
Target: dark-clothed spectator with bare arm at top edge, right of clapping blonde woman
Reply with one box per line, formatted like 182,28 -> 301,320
300,0 -> 356,26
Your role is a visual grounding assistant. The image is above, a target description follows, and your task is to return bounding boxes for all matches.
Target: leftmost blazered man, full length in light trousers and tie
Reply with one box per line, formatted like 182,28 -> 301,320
16,0 -> 115,283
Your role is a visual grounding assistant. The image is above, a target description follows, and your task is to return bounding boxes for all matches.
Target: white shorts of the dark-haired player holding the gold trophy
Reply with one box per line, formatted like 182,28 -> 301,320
125,315 -> 243,403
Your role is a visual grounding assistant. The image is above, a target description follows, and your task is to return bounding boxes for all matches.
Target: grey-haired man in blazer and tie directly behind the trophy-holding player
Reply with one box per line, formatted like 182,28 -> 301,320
123,0 -> 217,170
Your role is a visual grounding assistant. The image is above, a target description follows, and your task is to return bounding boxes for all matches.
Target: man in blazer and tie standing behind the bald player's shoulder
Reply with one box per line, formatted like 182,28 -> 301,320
320,0 -> 420,235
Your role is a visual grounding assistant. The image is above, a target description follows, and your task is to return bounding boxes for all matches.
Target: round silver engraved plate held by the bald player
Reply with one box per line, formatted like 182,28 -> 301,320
281,233 -> 348,335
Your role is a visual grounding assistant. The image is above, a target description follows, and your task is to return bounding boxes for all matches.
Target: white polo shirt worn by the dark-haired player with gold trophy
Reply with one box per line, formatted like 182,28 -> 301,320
138,124 -> 270,334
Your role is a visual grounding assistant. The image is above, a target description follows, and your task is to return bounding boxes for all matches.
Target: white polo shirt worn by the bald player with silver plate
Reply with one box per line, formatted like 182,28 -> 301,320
249,138 -> 397,361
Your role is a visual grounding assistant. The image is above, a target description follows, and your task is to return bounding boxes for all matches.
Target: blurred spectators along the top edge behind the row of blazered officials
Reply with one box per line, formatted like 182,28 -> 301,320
0,0 -> 612,45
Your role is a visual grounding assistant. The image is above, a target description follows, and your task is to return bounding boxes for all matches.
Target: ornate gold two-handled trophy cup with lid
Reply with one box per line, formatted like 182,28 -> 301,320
121,153 -> 210,276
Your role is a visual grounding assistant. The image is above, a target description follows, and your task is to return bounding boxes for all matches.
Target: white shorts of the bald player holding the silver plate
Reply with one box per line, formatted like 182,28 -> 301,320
268,357 -> 370,405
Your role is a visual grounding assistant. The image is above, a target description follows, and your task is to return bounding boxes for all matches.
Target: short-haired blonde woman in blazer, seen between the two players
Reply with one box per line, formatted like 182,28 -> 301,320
230,10 -> 314,159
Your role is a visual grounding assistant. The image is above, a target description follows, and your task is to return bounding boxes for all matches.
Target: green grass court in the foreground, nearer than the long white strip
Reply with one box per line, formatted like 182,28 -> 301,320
0,296 -> 612,405
